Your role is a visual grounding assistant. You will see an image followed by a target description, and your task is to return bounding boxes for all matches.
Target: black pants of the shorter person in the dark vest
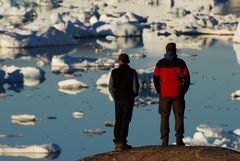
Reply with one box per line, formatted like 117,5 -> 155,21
113,100 -> 134,144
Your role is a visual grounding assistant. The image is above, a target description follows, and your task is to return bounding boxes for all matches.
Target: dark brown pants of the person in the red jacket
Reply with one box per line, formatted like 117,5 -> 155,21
159,96 -> 185,139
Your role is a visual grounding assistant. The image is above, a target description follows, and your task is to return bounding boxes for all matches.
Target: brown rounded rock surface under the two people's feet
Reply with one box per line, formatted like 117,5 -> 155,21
78,146 -> 240,161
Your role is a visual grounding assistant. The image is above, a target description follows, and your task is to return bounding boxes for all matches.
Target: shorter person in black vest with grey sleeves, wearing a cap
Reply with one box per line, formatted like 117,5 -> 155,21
109,54 -> 139,151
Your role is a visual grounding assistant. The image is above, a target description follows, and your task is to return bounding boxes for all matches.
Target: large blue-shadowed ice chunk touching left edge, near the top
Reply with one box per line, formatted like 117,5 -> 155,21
0,27 -> 77,48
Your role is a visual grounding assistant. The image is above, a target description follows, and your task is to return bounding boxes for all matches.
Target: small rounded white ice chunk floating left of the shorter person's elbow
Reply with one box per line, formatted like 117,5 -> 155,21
58,79 -> 88,91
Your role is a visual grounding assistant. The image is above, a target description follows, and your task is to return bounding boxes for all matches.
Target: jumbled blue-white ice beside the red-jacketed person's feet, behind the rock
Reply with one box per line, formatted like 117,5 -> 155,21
184,124 -> 240,151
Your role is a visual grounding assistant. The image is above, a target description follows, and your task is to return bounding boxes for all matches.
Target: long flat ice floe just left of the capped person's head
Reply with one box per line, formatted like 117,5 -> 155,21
51,55 -> 117,73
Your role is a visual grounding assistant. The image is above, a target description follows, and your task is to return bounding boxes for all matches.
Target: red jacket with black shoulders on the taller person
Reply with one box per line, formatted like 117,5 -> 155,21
153,56 -> 190,97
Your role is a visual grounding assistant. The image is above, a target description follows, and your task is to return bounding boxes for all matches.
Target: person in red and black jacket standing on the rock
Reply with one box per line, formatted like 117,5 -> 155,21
153,43 -> 190,146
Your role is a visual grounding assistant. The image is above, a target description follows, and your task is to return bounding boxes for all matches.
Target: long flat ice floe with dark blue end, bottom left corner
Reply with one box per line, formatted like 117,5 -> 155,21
0,144 -> 61,159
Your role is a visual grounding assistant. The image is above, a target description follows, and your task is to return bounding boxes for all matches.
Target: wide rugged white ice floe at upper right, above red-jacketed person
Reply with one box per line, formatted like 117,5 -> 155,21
172,13 -> 238,36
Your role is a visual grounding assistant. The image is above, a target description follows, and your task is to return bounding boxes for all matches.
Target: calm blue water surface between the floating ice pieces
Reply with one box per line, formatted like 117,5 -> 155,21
0,34 -> 240,161
